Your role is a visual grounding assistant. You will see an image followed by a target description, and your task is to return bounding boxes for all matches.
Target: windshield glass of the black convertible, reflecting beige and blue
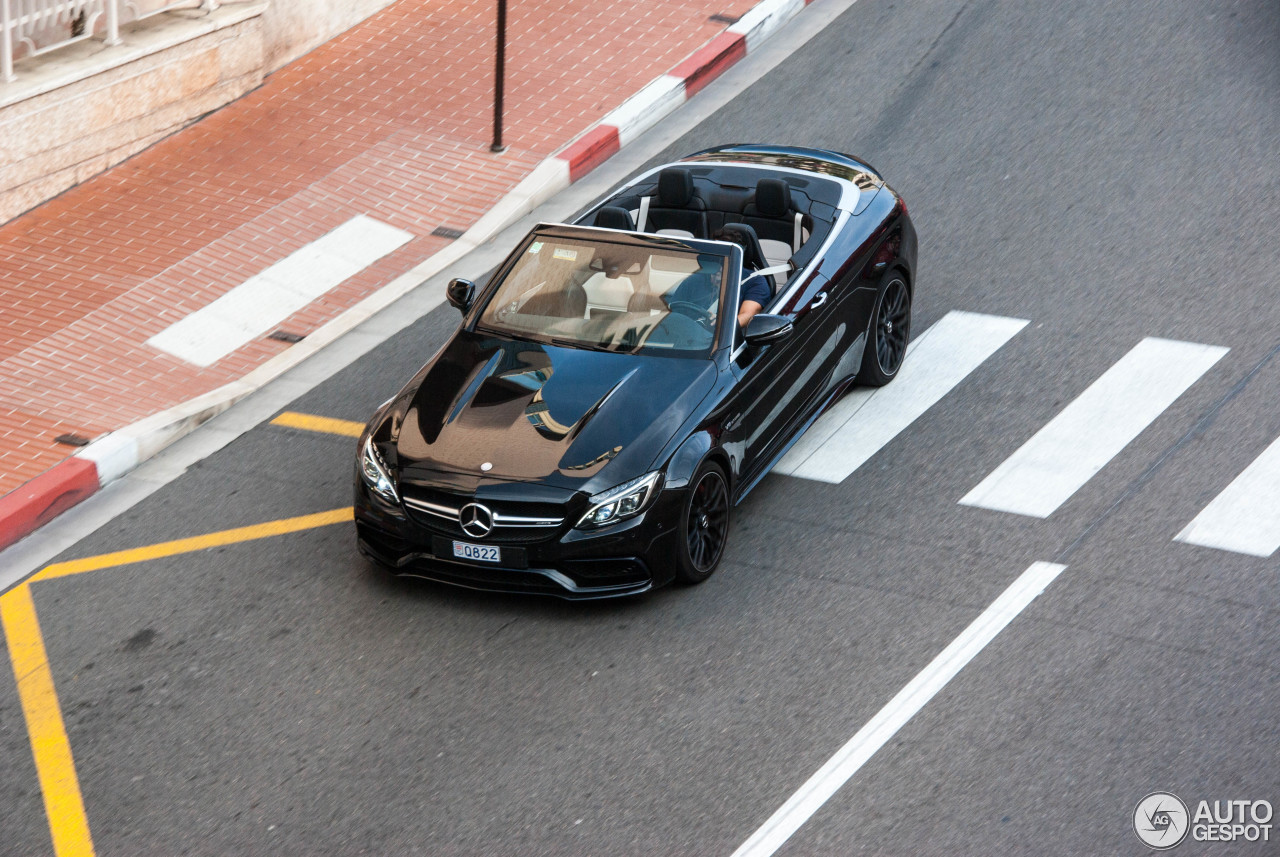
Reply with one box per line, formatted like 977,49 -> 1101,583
479,234 -> 726,357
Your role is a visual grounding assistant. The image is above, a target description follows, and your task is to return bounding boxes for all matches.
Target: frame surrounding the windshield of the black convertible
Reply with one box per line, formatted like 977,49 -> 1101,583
463,224 -> 742,359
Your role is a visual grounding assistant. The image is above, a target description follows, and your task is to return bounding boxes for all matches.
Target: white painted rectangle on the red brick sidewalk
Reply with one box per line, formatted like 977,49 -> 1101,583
147,215 -> 413,366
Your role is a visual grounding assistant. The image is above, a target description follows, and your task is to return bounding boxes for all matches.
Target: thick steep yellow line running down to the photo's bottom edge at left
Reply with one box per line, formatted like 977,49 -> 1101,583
0,583 -> 93,857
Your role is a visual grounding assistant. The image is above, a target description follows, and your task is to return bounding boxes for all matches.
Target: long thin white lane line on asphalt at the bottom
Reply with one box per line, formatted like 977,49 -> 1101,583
733,563 -> 1066,857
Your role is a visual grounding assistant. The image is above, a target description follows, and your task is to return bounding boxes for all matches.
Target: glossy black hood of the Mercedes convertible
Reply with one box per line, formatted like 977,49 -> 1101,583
390,330 -> 716,492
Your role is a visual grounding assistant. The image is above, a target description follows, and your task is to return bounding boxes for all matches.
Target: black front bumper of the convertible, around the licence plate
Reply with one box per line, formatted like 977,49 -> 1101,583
355,477 -> 684,600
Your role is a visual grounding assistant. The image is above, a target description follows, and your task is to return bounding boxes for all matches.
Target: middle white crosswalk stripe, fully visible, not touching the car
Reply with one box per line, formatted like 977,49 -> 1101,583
960,336 -> 1228,518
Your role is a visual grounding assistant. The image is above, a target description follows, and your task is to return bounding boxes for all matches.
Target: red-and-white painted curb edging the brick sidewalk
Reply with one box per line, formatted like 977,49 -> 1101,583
0,0 -> 813,550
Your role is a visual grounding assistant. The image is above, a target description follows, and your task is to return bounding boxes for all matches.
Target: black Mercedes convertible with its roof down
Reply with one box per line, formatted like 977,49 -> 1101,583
355,146 -> 916,599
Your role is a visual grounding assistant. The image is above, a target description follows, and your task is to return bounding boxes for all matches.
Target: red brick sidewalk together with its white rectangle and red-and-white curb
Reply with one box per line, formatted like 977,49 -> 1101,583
0,0 -> 805,547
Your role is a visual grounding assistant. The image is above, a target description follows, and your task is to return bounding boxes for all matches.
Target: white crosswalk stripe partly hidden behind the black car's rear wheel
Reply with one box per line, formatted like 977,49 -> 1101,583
773,311 -> 1027,482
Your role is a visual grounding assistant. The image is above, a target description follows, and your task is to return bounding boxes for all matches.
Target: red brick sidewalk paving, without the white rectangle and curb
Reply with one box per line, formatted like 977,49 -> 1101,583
0,0 -> 755,495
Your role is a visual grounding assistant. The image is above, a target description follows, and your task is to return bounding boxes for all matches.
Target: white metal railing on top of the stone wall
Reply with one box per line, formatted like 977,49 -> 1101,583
0,0 -> 220,83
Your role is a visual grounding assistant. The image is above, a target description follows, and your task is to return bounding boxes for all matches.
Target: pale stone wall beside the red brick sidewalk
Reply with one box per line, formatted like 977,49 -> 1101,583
0,0 -> 390,224
